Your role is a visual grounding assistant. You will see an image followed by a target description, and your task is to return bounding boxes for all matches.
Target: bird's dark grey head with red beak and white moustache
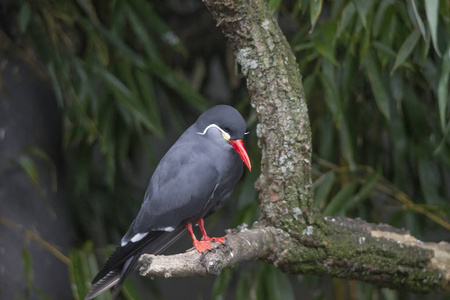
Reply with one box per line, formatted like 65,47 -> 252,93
196,105 -> 252,171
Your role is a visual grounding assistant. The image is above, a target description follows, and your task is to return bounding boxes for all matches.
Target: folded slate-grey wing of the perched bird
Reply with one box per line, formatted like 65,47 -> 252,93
122,145 -> 220,245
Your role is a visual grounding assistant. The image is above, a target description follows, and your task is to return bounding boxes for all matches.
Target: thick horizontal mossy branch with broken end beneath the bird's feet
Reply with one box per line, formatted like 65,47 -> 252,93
140,217 -> 450,293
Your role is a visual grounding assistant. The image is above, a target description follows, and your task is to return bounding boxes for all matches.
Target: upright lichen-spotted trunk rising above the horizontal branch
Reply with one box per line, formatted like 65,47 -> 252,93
205,0 -> 312,230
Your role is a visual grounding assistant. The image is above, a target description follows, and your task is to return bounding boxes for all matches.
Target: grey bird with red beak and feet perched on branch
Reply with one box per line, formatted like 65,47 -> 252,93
85,105 -> 251,300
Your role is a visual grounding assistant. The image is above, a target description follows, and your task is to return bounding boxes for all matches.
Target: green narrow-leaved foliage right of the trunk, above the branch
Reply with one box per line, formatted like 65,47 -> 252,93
292,0 -> 450,232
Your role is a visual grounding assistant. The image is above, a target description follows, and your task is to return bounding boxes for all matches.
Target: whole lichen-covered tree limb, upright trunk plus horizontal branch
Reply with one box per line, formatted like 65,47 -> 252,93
141,0 -> 450,293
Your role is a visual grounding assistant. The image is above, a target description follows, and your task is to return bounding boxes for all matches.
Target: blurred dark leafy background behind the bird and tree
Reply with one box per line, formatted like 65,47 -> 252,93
0,0 -> 450,300
